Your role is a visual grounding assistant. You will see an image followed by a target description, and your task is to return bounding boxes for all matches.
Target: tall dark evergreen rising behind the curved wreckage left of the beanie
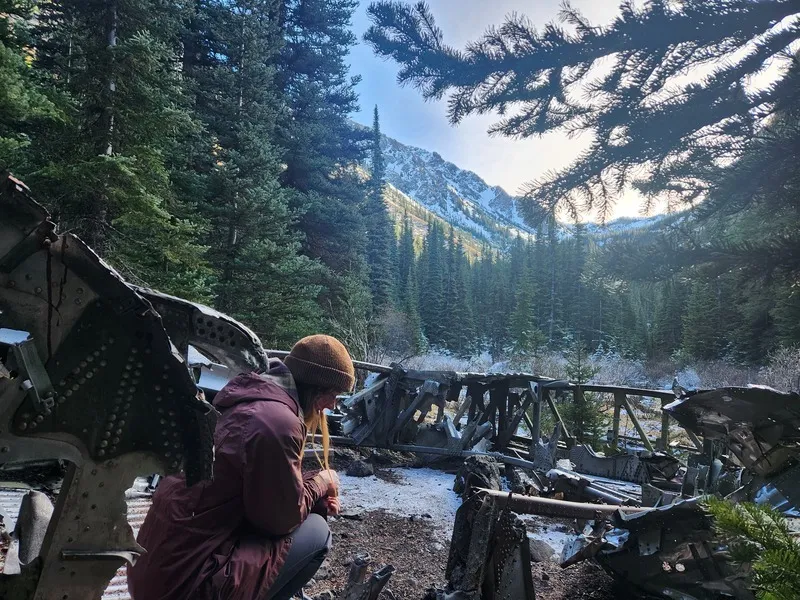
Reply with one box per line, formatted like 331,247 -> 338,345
191,0 -> 321,346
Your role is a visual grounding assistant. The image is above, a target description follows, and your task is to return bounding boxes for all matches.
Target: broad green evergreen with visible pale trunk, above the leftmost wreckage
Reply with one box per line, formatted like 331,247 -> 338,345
19,0 -> 208,298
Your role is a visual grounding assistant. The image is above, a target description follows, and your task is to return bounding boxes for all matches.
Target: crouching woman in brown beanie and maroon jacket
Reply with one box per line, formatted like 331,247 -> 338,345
128,335 -> 355,600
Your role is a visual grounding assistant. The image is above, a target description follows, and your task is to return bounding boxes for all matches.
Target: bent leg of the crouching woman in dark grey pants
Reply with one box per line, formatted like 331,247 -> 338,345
267,513 -> 331,600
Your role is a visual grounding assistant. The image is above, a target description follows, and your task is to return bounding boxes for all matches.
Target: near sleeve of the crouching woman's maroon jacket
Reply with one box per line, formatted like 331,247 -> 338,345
242,406 -> 325,536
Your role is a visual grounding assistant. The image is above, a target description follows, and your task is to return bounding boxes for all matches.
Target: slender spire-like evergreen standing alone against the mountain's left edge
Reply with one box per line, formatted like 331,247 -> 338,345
364,106 -> 397,308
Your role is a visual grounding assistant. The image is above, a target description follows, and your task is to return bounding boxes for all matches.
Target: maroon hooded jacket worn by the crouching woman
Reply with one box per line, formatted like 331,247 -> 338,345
128,361 -> 325,600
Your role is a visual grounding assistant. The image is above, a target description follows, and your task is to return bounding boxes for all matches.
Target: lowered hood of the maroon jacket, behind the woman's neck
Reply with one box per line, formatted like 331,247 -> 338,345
214,358 -> 302,415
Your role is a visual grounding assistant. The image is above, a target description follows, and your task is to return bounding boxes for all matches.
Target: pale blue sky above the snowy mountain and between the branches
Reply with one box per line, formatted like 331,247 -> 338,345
350,0 -> 638,216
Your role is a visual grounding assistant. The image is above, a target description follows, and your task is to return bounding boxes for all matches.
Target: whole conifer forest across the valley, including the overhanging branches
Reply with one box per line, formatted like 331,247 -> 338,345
0,0 -> 800,382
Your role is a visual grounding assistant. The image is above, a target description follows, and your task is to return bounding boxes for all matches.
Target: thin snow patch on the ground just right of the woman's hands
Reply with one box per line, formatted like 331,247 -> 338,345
339,468 -> 461,541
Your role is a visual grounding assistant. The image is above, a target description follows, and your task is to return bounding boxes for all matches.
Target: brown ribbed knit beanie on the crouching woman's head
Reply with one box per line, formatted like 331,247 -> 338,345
283,335 -> 356,392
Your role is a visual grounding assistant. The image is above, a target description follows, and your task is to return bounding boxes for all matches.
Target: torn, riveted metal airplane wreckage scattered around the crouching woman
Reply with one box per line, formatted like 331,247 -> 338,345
0,171 -> 800,600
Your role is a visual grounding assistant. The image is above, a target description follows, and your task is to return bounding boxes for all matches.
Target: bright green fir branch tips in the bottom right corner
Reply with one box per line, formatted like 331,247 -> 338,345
706,497 -> 800,600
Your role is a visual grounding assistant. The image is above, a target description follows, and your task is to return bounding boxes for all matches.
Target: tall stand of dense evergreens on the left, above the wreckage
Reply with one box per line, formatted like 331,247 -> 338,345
0,0 -> 370,346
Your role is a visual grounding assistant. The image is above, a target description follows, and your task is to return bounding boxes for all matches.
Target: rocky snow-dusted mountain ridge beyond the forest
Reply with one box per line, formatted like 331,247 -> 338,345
370,127 -> 662,247
